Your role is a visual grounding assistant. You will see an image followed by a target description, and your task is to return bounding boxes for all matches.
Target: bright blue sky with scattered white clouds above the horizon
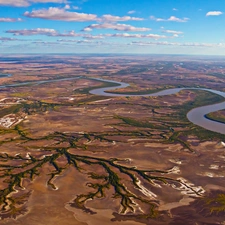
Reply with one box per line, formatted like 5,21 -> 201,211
0,0 -> 225,55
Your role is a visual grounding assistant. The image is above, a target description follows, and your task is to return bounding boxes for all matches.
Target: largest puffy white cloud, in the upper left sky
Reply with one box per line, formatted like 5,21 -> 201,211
24,7 -> 97,22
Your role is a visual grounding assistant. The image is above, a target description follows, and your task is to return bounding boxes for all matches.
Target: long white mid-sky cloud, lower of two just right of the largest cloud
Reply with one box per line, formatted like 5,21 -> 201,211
83,23 -> 151,32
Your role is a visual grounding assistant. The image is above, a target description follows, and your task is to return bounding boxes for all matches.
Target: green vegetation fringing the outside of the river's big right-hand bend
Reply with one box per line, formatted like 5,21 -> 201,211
110,90 -> 224,152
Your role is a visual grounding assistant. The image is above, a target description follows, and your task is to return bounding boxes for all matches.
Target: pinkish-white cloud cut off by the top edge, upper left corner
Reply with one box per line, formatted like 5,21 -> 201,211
0,0 -> 67,7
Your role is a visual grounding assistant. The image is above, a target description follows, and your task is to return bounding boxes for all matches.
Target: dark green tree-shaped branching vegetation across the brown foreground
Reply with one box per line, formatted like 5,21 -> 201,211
0,126 -> 199,219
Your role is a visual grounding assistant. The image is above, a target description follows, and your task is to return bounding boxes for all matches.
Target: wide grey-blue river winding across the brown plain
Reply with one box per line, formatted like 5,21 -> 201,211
0,74 -> 225,134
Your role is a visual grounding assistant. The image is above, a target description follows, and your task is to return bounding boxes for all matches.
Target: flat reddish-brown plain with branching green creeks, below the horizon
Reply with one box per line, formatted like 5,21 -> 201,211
0,55 -> 225,225
